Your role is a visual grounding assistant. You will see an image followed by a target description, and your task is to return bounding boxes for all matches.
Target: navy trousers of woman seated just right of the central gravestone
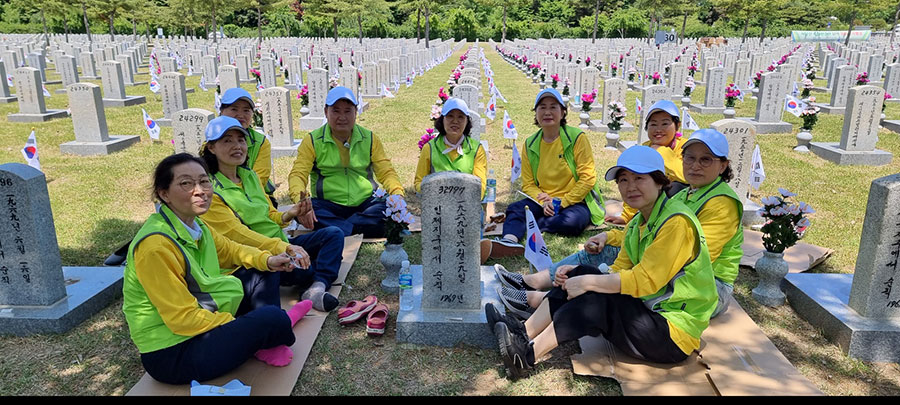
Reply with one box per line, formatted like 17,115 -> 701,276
503,198 -> 591,240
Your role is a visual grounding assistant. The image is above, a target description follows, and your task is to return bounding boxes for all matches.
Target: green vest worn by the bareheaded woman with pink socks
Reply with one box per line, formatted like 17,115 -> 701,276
122,204 -> 244,353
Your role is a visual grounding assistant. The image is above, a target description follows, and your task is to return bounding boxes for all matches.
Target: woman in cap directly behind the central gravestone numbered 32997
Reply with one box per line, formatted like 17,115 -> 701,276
414,98 -> 487,198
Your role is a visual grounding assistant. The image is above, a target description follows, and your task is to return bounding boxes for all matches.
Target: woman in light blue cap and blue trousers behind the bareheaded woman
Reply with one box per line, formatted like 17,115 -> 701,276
200,117 -> 344,312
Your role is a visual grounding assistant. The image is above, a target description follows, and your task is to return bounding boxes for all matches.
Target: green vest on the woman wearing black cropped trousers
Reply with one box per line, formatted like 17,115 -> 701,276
623,193 -> 718,339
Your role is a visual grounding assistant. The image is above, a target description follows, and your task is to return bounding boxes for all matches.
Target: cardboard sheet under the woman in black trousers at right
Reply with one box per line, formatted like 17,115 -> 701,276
571,298 -> 823,396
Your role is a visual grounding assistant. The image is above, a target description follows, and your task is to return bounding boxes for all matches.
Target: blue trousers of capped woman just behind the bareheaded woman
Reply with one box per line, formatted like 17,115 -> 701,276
284,224 -> 344,291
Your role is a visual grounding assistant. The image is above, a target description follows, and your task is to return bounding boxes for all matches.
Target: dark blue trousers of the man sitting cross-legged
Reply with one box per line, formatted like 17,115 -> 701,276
311,197 -> 387,238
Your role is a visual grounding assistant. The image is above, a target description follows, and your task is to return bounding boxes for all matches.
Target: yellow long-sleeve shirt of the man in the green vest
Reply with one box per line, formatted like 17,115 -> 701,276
288,129 -> 403,203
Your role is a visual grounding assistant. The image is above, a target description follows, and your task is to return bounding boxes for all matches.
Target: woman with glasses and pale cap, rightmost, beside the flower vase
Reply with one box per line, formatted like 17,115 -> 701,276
495,129 -> 744,318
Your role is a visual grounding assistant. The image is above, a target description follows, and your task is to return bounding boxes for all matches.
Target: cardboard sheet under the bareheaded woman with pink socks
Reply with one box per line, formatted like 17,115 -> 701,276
126,235 -> 362,396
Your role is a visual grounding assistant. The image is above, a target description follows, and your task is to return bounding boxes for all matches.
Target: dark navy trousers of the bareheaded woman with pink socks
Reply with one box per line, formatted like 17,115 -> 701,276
141,305 -> 296,384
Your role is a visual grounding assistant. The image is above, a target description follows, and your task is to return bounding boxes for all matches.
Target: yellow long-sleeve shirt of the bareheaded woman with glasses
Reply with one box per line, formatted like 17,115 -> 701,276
134,227 -> 272,336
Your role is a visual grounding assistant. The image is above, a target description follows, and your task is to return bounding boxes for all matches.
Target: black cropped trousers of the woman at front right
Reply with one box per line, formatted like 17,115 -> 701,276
547,265 -> 687,363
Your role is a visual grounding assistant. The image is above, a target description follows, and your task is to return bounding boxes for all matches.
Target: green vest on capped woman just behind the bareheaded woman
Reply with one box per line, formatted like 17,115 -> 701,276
213,166 -> 288,242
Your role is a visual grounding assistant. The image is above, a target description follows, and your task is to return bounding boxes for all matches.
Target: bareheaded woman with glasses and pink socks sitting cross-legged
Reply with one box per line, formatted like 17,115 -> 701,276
122,153 -> 312,384
